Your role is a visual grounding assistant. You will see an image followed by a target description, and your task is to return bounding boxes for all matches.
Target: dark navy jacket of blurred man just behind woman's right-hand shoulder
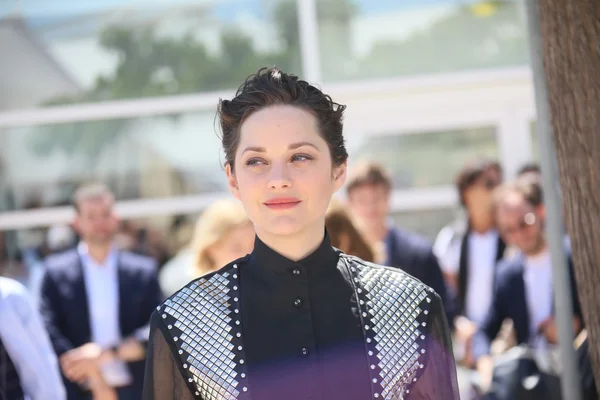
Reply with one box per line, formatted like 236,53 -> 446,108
384,227 -> 456,326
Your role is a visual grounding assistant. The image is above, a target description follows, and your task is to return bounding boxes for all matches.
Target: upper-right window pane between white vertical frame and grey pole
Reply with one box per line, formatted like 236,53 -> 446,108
317,0 -> 527,81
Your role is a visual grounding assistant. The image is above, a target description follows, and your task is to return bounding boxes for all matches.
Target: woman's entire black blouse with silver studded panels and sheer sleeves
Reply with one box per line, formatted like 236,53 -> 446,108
143,235 -> 459,400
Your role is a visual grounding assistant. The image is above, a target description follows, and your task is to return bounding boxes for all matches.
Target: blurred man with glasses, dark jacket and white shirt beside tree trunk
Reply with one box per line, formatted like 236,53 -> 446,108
472,176 -> 583,389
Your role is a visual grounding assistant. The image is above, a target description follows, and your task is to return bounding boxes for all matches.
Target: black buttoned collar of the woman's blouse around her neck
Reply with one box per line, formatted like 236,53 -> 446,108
251,230 -> 339,279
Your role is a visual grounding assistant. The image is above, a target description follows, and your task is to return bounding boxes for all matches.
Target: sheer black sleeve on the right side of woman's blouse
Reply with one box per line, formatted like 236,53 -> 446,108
405,294 -> 460,400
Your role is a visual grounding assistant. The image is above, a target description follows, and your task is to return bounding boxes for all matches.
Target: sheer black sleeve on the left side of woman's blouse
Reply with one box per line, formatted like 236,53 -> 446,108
142,312 -> 194,400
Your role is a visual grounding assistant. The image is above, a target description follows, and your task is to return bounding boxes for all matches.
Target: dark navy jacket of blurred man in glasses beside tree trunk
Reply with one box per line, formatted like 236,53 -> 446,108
473,256 -> 583,358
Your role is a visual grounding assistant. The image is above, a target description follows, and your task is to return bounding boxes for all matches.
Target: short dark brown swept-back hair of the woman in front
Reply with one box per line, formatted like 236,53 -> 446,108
217,68 -> 348,169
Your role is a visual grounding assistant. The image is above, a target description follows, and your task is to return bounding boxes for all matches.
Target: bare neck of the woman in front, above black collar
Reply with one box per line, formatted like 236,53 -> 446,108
255,220 -> 325,261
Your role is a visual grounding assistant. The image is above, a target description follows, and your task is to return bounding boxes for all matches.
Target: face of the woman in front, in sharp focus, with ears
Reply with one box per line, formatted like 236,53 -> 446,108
227,105 -> 346,239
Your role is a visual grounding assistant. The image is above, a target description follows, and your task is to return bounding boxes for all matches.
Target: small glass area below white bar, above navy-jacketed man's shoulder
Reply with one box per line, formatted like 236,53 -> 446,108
391,208 -> 456,242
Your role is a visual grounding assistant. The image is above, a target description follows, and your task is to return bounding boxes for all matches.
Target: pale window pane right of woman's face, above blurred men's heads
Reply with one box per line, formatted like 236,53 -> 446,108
351,127 -> 498,189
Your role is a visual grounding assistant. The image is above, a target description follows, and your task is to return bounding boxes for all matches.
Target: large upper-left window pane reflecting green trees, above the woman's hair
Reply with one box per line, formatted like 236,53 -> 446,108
0,0 -> 301,110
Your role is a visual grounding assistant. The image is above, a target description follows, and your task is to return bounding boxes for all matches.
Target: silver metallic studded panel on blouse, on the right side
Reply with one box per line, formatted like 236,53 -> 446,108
347,258 -> 433,400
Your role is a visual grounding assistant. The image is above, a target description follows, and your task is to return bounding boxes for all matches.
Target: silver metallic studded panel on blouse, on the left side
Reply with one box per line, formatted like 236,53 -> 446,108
159,266 -> 248,400
